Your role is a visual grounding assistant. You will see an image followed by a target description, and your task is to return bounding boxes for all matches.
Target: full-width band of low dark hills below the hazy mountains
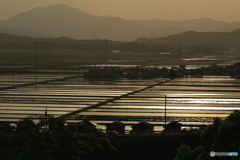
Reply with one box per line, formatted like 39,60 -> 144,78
0,29 -> 240,52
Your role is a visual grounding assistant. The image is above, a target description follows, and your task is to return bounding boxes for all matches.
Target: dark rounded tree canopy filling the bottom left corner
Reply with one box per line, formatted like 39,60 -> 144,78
0,117 -> 116,160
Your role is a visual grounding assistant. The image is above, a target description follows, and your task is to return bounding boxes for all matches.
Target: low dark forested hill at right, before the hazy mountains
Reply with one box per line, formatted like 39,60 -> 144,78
135,29 -> 240,47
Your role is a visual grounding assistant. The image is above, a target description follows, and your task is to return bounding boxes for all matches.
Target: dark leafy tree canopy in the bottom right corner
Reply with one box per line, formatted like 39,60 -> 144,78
175,111 -> 240,160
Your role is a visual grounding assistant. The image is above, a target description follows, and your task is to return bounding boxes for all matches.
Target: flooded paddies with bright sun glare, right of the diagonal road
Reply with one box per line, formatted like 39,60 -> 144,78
79,76 -> 240,129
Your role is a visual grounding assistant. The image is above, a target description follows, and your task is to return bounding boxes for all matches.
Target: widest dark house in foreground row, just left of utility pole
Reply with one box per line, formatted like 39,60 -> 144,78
130,121 -> 154,134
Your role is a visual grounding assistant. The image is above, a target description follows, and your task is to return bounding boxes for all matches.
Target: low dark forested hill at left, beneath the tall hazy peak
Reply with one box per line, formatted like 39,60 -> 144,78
0,33 -> 123,52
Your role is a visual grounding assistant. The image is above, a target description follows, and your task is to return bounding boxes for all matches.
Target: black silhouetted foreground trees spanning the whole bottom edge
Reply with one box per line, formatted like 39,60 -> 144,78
0,111 -> 240,160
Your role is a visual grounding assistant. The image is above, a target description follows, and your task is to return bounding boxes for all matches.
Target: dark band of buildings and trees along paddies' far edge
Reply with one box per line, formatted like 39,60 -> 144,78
84,62 -> 240,79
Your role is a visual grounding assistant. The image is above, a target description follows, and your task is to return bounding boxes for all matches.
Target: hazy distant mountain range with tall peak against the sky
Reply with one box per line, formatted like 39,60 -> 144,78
0,4 -> 240,41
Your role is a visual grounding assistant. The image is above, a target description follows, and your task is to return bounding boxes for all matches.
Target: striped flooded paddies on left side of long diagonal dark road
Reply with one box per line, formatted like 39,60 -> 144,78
0,77 -> 156,121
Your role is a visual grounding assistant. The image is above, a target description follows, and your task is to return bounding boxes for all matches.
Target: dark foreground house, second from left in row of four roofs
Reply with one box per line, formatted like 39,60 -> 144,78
106,121 -> 125,134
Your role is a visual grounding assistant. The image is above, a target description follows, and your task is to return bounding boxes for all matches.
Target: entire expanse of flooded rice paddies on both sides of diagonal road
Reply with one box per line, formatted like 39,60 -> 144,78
0,73 -> 240,131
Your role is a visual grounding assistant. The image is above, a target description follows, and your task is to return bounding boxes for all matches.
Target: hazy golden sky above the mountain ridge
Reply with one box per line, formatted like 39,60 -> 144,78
0,0 -> 240,22
